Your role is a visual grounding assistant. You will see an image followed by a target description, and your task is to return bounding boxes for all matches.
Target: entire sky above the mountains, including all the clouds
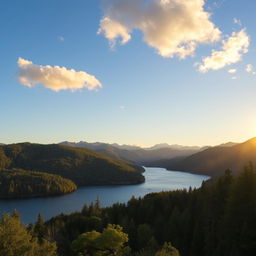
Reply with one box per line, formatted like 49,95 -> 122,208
0,0 -> 256,146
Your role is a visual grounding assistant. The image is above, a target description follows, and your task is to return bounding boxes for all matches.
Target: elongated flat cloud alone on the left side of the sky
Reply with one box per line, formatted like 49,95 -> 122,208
17,58 -> 102,92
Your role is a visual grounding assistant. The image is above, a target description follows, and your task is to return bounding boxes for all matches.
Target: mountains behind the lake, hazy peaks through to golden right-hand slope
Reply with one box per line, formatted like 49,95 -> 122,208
61,138 -> 256,176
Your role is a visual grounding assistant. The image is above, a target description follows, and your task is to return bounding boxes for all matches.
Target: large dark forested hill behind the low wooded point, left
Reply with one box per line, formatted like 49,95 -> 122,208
0,143 -> 144,186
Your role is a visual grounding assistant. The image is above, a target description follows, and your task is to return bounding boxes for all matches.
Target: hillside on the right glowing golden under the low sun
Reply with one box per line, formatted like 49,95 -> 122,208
164,138 -> 256,176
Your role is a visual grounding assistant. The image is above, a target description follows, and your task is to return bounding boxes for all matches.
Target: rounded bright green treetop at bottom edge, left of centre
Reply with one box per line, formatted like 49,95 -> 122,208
72,224 -> 128,256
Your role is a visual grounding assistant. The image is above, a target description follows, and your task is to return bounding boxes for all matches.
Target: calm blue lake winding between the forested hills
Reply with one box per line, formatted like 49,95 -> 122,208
0,168 -> 209,223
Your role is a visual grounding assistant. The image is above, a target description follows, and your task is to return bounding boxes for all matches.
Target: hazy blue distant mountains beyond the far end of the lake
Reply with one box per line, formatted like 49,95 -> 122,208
60,141 -> 200,165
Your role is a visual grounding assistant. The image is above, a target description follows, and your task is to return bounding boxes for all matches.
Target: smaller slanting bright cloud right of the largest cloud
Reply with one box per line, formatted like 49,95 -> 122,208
199,29 -> 250,72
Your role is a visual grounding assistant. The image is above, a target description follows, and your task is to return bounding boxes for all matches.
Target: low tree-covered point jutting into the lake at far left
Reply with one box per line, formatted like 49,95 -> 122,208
0,169 -> 77,198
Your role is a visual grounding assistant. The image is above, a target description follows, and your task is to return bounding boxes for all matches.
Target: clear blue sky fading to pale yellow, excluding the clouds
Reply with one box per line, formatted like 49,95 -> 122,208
0,0 -> 256,146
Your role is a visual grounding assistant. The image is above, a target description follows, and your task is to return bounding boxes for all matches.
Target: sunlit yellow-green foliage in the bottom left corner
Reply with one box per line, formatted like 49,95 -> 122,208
0,215 -> 56,256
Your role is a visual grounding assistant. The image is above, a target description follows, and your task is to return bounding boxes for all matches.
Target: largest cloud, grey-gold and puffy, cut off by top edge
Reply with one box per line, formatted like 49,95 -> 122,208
98,0 -> 221,58
